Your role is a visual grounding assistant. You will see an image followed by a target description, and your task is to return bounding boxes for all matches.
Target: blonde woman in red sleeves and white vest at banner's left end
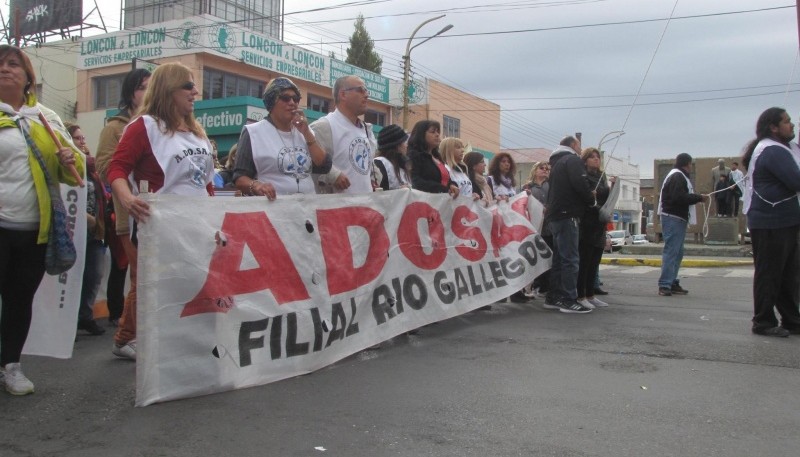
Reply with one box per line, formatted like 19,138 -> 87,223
108,63 -> 214,359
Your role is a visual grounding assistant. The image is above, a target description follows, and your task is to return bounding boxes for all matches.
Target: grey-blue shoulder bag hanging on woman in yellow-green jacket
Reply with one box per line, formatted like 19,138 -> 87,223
16,119 -> 78,276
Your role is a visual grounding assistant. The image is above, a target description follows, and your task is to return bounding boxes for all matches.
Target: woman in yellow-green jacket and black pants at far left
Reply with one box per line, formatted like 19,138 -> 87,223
0,45 -> 84,395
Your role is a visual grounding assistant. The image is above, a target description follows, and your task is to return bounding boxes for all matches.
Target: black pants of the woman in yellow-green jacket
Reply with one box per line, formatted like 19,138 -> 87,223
0,228 -> 47,366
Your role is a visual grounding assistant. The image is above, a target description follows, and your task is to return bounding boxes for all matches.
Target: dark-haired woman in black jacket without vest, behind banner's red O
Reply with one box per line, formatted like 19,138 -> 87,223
408,120 -> 458,198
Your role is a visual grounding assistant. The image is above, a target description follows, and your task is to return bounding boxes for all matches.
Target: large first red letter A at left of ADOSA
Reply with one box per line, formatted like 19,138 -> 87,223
181,212 -> 309,317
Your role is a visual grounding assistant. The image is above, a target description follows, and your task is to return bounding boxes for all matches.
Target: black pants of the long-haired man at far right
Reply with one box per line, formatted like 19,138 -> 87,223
750,225 -> 800,329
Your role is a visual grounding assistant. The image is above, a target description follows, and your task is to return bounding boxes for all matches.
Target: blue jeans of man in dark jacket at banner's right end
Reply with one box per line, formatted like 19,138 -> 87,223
548,218 -> 580,300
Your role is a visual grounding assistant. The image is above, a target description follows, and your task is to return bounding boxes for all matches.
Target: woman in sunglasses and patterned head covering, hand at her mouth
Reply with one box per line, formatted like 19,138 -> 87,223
233,77 -> 326,200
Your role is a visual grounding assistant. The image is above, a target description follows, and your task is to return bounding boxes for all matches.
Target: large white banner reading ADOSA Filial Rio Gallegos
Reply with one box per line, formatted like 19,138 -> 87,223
136,190 -> 552,406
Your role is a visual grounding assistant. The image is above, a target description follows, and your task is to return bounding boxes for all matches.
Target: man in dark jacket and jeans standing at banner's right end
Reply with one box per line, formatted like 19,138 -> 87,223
543,136 -> 594,314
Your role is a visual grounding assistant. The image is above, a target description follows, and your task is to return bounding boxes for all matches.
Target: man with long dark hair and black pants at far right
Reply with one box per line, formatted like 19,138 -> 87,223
742,108 -> 800,337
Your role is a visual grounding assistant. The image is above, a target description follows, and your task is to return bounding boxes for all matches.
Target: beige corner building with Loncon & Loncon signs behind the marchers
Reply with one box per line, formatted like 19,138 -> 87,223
26,15 -> 500,162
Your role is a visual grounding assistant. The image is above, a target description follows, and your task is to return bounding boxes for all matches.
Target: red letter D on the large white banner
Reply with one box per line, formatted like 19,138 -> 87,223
317,207 -> 389,295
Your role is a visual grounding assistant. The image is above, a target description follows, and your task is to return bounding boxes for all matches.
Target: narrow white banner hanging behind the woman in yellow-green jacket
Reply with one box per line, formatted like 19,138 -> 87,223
22,181 -> 86,359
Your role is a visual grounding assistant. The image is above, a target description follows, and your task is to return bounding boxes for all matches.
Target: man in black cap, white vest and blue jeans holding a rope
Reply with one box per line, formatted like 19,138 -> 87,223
658,153 -> 708,296
